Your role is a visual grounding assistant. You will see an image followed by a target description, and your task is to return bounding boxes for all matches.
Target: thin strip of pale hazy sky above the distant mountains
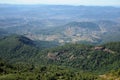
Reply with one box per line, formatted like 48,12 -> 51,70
0,0 -> 120,6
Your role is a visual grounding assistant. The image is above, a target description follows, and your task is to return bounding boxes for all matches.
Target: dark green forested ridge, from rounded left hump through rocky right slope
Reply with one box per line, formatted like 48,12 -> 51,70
0,35 -> 120,73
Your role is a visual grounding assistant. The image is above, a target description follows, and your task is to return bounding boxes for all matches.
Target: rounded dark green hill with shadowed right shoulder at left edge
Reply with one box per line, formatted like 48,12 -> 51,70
0,35 -> 37,62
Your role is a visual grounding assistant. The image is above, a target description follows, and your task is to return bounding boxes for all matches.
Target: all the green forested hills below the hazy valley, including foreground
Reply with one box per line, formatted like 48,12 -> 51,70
0,35 -> 120,80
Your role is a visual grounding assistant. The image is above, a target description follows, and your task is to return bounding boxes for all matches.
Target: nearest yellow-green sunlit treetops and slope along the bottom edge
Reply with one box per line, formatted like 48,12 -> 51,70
0,59 -> 120,80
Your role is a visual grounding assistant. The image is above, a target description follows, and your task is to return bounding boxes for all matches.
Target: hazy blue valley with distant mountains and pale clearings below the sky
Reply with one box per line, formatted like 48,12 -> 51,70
0,5 -> 120,44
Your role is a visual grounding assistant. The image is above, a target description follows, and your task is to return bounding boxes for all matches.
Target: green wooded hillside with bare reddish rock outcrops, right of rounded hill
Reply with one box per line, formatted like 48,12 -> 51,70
35,42 -> 120,73
